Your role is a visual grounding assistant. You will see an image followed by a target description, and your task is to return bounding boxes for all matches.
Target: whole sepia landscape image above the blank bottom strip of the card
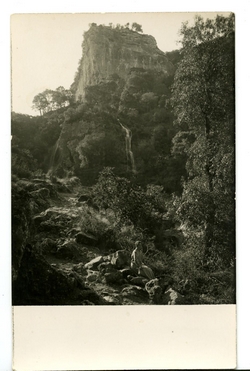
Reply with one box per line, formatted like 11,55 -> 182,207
11,13 -> 236,306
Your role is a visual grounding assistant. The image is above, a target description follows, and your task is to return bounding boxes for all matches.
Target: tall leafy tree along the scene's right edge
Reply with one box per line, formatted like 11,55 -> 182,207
172,14 -> 234,263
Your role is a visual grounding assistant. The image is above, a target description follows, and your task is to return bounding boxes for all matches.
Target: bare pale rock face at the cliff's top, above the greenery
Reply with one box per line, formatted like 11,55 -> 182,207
74,25 -> 174,99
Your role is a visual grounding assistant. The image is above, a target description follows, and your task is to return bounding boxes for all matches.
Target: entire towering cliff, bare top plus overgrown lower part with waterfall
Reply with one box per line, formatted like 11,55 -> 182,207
48,26 -> 180,190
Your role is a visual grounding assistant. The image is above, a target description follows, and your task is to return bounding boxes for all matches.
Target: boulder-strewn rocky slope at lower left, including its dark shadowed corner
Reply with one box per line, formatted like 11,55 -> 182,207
12,178 -> 185,305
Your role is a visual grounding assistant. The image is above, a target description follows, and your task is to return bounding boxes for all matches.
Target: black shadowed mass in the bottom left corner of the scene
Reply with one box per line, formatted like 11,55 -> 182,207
12,245 -> 100,305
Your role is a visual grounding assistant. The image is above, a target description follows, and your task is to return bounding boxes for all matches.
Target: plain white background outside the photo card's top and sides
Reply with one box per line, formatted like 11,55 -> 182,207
0,0 -> 250,371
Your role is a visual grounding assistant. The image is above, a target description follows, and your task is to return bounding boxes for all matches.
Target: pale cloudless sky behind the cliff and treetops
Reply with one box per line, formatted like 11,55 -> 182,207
11,13 -> 229,115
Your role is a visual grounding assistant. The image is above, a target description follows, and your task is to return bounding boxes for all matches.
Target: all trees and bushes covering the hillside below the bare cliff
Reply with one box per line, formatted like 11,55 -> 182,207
12,14 -> 235,304
